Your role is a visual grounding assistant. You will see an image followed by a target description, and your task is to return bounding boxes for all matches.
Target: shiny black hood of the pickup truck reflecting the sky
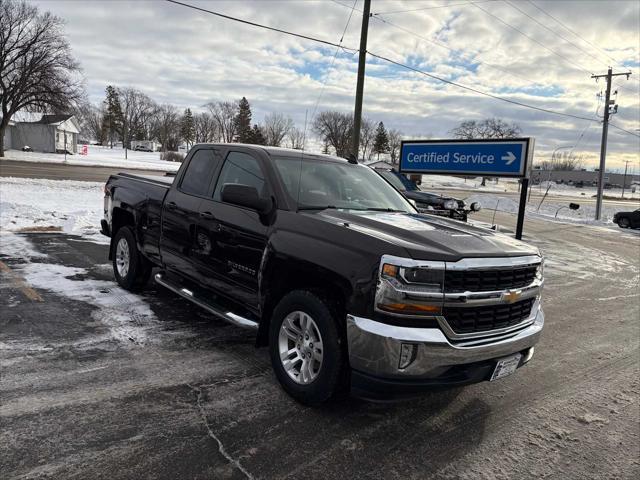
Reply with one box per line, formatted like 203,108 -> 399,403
305,210 -> 539,262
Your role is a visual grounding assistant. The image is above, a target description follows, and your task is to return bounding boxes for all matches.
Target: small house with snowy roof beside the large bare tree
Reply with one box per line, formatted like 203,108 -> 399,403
5,114 -> 80,153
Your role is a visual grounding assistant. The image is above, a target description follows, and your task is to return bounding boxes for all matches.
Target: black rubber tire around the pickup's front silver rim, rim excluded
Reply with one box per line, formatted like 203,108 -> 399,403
269,290 -> 348,405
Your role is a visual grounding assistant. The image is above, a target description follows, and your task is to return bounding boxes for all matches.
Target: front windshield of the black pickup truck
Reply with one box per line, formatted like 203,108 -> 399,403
274,157 -> 416,213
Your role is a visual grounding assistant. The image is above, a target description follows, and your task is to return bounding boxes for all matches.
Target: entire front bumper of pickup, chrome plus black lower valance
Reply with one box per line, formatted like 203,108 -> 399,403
347,301 -> 544,399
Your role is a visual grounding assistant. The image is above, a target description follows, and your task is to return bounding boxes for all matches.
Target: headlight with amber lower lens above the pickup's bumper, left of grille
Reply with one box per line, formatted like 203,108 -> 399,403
375,255 -> 444,316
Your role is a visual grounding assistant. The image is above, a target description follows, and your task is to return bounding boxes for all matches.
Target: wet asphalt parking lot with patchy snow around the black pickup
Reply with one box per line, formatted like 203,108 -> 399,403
0,215 -> 640,479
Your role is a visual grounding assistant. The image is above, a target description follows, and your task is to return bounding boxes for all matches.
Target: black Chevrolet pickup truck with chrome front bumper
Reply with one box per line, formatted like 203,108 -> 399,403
102,144 -> 544,404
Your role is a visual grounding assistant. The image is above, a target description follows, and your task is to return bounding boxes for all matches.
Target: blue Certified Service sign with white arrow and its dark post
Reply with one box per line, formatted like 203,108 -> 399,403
400,138 -> 533,239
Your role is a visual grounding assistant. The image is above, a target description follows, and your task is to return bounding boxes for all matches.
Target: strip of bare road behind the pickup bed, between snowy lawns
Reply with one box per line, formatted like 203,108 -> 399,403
0,160 -> 170,182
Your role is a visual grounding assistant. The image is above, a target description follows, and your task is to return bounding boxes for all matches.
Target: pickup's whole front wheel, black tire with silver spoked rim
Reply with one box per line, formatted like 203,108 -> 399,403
269,290 -> 347,405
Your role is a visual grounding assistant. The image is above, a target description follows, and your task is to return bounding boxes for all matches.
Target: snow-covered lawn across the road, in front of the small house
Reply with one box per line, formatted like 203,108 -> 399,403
4,145 -> 180,172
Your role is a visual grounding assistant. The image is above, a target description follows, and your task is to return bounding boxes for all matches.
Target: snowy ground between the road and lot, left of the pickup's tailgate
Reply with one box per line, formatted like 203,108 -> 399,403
0,177 -> 106,240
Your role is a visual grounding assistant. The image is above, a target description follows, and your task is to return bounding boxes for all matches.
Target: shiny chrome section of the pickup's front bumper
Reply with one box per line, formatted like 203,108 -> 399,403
347,300 -> 544,380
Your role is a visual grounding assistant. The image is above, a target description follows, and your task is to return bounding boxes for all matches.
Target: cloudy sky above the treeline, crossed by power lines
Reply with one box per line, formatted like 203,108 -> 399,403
34,0 -> 640,173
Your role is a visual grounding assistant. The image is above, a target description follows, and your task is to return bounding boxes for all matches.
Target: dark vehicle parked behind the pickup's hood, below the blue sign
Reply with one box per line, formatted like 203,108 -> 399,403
374,168 -> 481,222
